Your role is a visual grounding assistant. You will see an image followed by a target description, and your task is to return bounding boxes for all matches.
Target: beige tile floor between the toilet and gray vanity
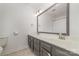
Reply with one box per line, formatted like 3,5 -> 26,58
5,48 -> 34,56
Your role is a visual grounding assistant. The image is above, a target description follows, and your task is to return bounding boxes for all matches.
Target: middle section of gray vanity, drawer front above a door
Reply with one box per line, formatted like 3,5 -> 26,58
40,41 -> 52,56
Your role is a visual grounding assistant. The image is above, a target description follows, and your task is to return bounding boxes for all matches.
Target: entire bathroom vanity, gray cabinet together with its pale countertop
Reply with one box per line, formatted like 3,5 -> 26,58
28,34 -> 79,56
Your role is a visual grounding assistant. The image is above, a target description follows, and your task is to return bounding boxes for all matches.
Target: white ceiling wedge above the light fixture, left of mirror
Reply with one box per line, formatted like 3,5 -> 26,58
26,3 -> 54,11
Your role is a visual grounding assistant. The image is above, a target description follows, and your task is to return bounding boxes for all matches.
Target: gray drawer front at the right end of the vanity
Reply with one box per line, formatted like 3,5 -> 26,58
52,46 -> 78,56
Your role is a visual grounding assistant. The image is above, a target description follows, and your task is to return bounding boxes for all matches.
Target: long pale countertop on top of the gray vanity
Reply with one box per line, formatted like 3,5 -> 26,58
29,34 -> 79,54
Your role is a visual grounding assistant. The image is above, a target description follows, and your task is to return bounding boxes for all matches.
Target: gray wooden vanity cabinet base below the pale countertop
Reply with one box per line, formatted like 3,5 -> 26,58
28,35 -> 79,56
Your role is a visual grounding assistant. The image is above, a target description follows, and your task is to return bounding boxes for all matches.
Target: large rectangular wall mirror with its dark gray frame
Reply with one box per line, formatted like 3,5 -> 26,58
37,3 -> 69,35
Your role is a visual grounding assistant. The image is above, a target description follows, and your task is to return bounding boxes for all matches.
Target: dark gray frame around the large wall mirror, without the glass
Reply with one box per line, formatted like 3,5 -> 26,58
37,3 -> 70,36
